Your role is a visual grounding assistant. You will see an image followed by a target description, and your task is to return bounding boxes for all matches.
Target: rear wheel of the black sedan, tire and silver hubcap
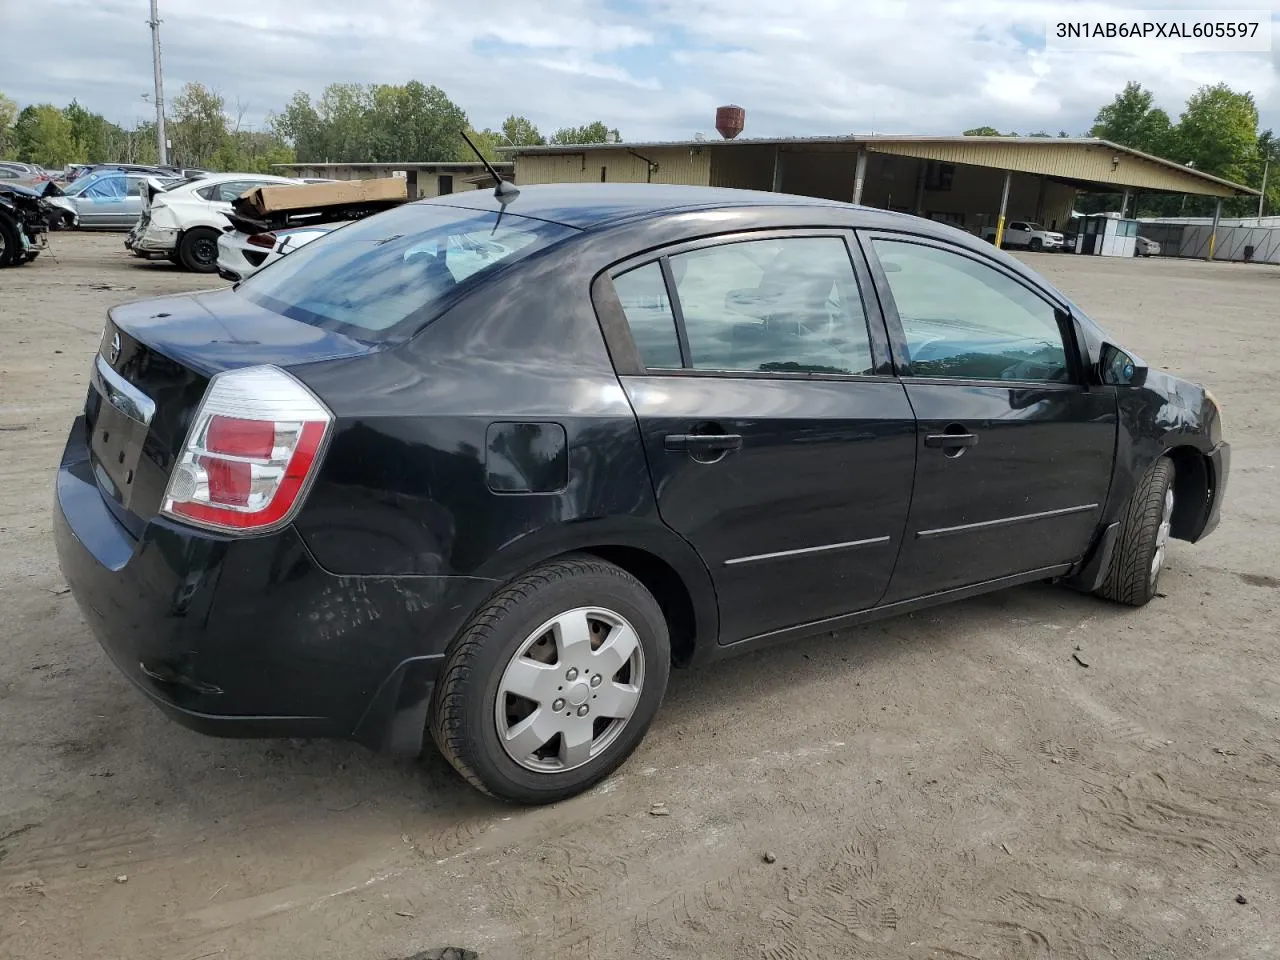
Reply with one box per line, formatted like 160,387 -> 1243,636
429,556 -> 671,804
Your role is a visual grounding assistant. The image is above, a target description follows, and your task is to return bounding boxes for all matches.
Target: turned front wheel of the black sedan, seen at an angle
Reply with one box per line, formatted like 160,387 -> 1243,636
1096,457 -> 1174,607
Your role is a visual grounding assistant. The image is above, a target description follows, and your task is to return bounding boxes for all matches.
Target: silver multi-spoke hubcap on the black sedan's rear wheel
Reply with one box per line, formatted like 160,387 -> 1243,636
494,607 -> 644,773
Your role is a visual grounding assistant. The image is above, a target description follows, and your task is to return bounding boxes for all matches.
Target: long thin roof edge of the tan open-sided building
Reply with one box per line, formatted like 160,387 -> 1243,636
498,133 -> 1258,197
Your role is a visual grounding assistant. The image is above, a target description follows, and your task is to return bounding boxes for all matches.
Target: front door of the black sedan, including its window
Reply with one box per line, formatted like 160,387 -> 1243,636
861,234 -> 1116,603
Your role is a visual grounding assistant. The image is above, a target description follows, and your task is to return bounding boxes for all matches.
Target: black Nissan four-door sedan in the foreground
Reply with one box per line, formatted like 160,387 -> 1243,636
55,184 -> 1229,803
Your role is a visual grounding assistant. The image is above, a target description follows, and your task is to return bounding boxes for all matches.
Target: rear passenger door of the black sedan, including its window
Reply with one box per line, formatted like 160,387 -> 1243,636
596,230 -> 915,643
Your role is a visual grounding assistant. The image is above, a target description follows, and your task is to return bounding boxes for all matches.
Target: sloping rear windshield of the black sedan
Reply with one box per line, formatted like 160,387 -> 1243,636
237,204 -> 577,340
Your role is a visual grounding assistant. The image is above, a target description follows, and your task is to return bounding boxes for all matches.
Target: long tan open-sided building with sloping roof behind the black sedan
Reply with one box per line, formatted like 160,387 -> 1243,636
507,136 -> 1257,253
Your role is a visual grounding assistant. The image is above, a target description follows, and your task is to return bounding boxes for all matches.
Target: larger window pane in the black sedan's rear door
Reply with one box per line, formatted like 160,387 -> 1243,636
671,237 -> 873,375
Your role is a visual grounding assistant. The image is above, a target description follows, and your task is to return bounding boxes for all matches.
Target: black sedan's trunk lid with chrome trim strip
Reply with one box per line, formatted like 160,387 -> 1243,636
84,289 -> 376,536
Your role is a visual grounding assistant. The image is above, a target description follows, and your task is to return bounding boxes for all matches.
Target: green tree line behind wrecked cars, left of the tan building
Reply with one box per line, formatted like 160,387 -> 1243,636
0,81 -> 622,173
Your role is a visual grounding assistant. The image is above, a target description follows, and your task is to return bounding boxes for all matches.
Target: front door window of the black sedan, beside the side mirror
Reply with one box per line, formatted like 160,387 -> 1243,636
872,238 -> 1069,381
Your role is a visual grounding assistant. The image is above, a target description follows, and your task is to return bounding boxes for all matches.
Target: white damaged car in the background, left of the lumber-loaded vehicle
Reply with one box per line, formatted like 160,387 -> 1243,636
124,173 -> 300,274
